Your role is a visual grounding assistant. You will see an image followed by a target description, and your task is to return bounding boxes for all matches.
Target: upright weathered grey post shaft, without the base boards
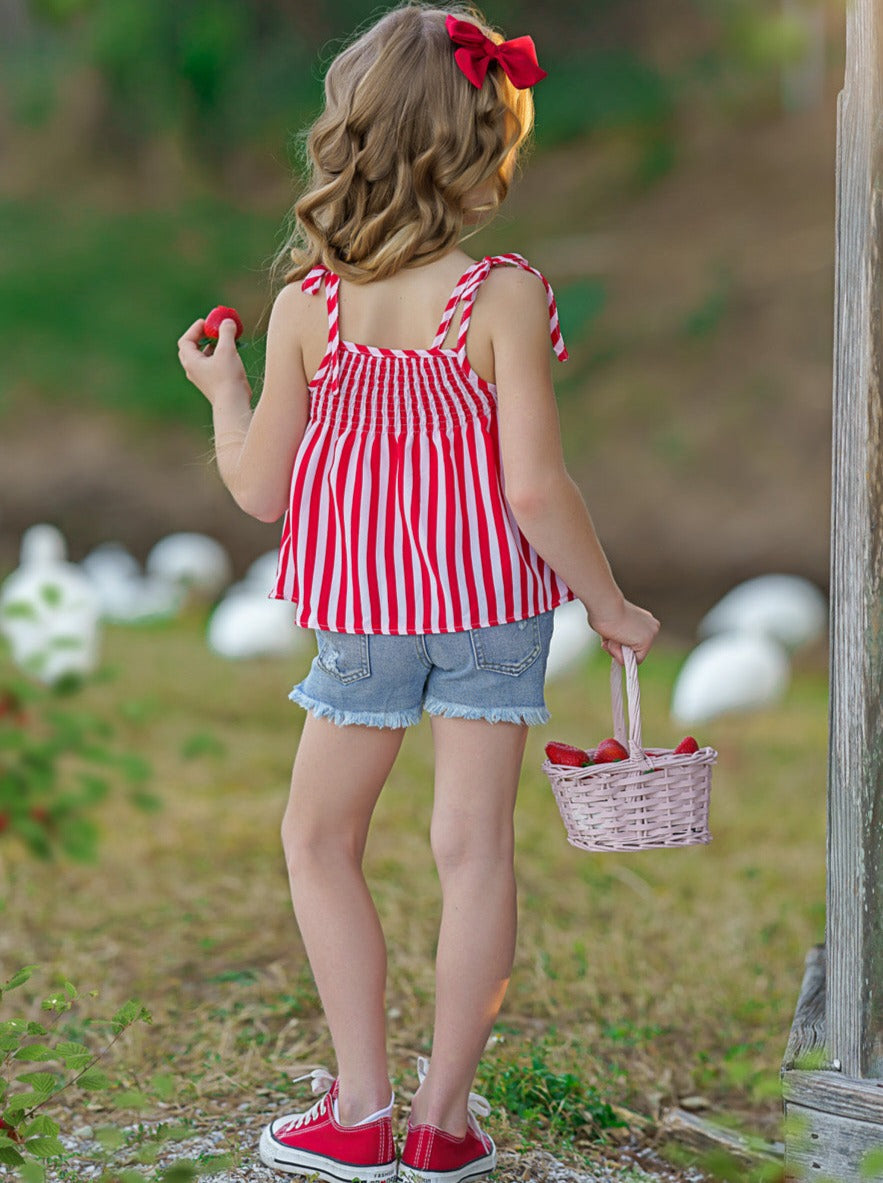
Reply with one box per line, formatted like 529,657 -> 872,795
825,0 -> 883,1078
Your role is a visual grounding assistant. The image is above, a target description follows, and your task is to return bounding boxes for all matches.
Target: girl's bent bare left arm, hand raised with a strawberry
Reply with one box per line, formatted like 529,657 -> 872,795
178,286 -> 311,522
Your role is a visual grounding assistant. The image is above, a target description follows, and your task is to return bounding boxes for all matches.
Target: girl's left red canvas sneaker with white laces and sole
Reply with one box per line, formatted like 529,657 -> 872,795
260,1068 -> 397,1183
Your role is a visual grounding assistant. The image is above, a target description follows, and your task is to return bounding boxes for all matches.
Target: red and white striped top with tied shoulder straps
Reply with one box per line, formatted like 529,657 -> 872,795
271,254 -> 574,634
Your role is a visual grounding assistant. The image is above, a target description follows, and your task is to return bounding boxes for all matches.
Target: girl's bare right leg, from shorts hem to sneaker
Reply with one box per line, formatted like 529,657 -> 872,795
411,717 -> 527,1137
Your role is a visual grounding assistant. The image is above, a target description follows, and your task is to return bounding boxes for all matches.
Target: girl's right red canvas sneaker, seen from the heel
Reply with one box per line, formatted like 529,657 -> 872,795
399,1056 -> 497,1183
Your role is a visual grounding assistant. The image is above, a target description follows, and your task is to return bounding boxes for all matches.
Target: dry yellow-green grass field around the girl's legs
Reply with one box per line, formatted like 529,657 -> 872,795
0,610 -> 827,1178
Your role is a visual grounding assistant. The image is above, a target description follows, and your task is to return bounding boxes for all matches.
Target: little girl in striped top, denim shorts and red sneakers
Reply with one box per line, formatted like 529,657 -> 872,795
179,2 -> 659,1183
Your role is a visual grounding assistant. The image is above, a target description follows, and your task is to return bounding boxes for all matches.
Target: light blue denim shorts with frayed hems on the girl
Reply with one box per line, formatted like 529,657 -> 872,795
289,612 -> 553,728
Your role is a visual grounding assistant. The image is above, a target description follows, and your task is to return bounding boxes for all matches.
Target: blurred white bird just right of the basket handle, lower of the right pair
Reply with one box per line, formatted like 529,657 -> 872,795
671,633 -> 789,724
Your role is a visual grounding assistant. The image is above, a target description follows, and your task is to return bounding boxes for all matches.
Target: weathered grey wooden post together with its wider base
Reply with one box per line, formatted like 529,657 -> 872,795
782,0 -> 883,1183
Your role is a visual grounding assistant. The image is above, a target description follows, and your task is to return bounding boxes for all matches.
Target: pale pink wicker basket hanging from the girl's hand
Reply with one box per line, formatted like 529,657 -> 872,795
542,646 -> 717,851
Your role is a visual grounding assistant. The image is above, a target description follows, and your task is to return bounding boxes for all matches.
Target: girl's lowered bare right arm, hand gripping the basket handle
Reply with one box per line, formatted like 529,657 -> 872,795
489,270 -> 659,661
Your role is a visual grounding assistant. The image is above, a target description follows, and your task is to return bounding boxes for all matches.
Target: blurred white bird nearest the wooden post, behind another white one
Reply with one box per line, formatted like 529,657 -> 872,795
698,575 -> 827,651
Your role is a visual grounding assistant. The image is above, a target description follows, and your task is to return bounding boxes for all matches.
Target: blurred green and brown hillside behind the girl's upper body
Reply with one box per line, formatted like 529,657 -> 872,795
0,0 -> 845,635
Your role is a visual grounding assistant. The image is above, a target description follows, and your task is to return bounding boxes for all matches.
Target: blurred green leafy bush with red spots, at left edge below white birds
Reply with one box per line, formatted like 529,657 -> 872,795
0,667 -> 156,860
